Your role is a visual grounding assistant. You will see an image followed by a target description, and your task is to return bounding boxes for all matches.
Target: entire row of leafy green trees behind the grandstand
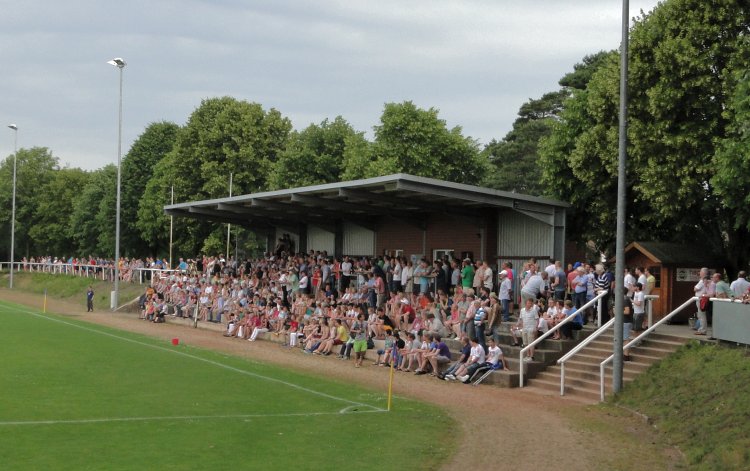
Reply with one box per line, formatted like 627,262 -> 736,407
0,0 -> 750,268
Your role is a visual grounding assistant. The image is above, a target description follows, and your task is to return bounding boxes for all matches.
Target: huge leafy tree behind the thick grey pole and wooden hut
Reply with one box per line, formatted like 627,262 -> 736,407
542,0 -> 750,270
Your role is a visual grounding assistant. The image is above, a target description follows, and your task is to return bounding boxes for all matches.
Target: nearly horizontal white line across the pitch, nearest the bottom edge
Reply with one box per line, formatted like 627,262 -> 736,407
0,412 -> 387,427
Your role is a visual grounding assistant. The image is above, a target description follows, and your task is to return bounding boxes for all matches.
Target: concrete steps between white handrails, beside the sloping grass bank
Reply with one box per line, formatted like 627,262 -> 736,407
528,330 -> 688,404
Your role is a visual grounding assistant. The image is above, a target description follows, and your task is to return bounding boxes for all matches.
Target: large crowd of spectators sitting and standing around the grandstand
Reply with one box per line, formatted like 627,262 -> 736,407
17,251 -> 750,380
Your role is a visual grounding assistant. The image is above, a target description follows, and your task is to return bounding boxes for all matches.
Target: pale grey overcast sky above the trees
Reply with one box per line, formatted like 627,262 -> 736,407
0,0 -> 657,169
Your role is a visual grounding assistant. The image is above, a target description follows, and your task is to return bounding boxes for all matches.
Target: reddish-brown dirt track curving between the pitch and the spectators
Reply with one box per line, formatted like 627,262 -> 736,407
0,289 -> 680,471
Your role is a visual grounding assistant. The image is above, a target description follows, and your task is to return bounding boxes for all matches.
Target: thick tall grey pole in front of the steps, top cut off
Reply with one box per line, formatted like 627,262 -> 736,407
612,0 -> 630,394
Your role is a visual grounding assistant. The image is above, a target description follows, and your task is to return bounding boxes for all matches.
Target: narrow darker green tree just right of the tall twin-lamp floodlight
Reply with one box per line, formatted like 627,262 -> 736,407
120,121 -> 180,256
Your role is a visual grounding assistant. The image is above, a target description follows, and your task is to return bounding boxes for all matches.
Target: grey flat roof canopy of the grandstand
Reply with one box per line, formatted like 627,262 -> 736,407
164,173 -> 570,231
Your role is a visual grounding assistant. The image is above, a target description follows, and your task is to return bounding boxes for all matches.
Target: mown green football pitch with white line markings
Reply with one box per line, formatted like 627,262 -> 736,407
0,302 -> 455,470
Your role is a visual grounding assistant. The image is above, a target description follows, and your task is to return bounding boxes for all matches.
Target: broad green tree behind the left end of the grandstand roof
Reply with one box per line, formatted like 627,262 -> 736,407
137,97 -> 291,255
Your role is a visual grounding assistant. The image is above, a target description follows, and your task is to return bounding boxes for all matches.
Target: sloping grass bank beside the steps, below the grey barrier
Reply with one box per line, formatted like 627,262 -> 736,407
612,341 -> 750,470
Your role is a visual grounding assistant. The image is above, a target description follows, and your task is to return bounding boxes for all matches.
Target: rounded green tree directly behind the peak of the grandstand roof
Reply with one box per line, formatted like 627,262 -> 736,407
344,101 -> 487,184
